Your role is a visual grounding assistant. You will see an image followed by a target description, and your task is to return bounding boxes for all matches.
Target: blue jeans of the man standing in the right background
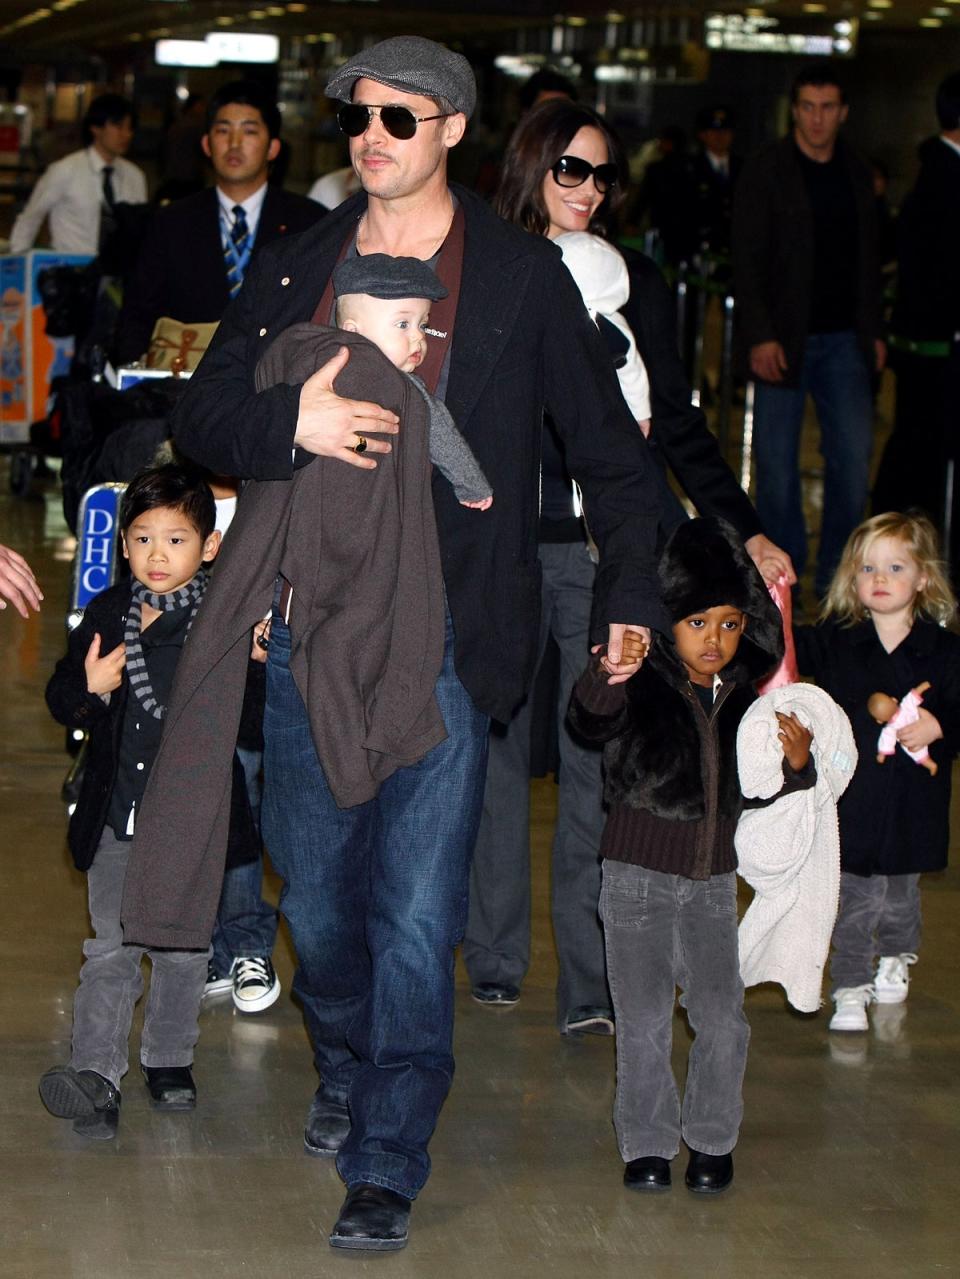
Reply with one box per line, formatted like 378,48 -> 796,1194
753,331 -> 873,596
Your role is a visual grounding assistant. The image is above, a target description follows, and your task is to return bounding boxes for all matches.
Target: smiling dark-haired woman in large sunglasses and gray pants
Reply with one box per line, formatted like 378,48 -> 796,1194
463,98 -> 794,1035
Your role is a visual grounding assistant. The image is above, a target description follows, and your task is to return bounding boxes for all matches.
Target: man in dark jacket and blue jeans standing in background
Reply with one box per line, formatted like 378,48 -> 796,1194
732,63 -> 886,596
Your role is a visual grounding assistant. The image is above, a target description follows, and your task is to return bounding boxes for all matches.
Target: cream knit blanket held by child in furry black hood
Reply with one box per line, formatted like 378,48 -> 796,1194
736,684 -> 856,1013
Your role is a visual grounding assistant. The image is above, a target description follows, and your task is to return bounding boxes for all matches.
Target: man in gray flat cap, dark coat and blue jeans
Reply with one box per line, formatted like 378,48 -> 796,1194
124,36 -> 666,1250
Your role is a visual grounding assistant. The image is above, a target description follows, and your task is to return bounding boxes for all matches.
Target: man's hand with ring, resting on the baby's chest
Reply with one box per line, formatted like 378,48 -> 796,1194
294,347 -> 400,471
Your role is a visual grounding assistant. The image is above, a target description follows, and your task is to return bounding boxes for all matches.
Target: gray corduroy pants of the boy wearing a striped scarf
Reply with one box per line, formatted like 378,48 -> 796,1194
70,826 -> 208,1087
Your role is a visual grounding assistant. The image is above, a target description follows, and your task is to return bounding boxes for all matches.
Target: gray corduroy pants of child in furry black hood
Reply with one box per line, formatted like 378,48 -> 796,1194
600,861 -> 750,1163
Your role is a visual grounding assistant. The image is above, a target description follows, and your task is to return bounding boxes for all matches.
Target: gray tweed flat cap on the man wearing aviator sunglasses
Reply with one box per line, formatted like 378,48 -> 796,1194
326,36 -> 477,120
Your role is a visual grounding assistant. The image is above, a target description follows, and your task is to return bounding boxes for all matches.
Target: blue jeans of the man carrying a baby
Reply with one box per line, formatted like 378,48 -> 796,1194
262,616 -> 490,1198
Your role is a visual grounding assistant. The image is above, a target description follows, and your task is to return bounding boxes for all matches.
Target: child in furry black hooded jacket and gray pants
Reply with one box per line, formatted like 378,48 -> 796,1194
570,519 -> 816,1193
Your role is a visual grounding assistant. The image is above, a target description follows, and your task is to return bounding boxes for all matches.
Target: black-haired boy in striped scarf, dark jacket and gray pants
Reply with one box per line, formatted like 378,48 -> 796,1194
40,463 -> 220,1140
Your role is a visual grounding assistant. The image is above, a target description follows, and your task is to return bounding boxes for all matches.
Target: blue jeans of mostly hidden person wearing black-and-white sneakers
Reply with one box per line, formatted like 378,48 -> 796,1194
212,746 -> 277,977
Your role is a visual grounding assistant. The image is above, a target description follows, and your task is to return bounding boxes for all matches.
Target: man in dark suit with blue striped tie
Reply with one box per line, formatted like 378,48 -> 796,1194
114,81 -> 325,363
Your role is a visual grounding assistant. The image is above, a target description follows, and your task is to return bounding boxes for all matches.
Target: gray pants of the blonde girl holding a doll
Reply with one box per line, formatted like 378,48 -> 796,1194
830,871 -> 920,995
